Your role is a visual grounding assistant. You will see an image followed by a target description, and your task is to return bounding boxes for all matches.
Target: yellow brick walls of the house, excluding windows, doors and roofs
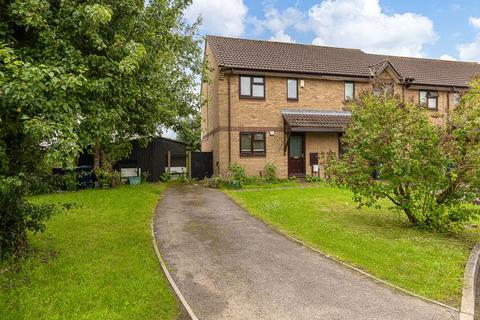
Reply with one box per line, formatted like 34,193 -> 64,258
201,44 -> 453,177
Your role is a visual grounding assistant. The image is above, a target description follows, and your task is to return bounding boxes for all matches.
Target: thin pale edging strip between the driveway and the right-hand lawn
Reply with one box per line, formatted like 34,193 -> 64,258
224,191 -> 458,312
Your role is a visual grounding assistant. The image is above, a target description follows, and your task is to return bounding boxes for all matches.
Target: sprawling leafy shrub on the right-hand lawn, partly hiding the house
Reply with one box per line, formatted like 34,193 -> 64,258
327,91 -> 480,230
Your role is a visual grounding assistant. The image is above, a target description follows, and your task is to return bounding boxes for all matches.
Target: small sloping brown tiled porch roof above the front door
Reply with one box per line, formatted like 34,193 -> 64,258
281,109 -> 351,132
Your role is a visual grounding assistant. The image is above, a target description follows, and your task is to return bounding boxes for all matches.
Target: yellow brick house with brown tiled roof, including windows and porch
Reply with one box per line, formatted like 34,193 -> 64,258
201,36 -> 480,177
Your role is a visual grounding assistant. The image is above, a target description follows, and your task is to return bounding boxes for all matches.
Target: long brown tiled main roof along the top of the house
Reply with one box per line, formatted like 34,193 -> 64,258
207,36 -> 480,87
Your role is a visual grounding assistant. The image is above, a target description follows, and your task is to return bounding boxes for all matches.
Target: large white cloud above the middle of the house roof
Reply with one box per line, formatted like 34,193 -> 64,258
302,0 -> 437,56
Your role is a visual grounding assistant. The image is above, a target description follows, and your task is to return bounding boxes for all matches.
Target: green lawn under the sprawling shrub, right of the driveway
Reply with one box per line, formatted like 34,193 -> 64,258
225,186 -> 480,307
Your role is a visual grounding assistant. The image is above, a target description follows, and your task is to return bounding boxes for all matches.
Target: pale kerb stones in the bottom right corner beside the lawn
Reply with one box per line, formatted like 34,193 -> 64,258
460,243 -> 480,320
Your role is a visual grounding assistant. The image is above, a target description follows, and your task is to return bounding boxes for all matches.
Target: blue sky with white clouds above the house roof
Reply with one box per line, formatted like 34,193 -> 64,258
186,0 -> 480,61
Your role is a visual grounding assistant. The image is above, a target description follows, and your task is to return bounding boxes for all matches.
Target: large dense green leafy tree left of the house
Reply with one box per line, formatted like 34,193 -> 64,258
0,0 -> 203,255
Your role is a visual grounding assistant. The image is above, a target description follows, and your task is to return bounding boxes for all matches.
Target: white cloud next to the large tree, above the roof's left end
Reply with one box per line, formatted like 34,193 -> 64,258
185,0 -> 248,37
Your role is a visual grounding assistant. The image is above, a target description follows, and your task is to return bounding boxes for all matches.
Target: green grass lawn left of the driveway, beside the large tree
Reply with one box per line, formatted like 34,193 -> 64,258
0,184 -> 178,319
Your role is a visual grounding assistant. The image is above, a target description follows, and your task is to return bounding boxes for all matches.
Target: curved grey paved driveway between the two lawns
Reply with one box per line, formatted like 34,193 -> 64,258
154,186 -> 457,320
